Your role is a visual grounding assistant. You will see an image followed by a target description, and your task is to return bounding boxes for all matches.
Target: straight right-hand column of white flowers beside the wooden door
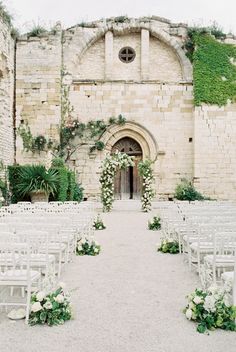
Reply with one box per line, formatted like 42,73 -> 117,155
138,159 -> 155,212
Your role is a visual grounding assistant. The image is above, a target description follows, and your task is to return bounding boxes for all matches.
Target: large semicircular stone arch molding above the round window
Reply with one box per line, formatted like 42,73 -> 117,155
77,20 -> 193,82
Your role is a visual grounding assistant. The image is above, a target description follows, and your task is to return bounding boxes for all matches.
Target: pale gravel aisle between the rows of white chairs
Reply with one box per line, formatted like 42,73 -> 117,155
0,202 -> 236,352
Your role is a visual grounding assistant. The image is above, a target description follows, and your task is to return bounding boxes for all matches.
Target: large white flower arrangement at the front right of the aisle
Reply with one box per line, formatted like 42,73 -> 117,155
184,286 -> 236,333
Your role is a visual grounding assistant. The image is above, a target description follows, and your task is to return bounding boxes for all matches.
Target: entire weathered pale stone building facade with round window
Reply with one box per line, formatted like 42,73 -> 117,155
0,17 -> 236,199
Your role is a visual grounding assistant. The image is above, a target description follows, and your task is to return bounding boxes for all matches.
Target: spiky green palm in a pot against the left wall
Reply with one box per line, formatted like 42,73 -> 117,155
17,165 -> 58,203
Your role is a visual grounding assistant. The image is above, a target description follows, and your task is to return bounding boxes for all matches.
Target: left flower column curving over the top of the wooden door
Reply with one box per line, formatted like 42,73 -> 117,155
100,152 -> 134,212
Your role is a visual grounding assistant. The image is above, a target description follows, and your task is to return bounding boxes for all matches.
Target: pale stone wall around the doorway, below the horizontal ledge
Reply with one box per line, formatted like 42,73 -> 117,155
70,82 -> 193,197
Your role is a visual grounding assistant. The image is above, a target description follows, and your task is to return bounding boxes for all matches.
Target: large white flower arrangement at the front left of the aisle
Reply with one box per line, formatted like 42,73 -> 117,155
29,284 -> 72,326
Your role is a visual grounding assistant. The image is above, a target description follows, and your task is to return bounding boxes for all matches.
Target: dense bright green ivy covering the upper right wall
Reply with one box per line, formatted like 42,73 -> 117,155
185,28 -> 236,106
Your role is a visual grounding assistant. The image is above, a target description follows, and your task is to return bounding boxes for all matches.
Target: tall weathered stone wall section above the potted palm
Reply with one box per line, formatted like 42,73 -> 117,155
16,28 -> 62,163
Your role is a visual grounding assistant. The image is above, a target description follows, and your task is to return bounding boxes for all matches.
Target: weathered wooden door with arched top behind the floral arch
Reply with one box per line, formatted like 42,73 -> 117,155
112,137 -> 143,199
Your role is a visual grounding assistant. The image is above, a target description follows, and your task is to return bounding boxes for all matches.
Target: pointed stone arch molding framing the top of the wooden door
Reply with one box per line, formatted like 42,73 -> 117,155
101,122 -> 158,162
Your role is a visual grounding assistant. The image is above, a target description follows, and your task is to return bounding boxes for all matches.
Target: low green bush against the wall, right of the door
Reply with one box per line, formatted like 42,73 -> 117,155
174,179 -> 208,201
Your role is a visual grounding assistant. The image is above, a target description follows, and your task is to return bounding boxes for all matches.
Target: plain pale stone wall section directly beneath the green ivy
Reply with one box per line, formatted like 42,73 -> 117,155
194,104 -> 236,199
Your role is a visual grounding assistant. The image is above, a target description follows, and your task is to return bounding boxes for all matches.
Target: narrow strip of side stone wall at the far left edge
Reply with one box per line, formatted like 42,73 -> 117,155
0,17 -> 14,173
